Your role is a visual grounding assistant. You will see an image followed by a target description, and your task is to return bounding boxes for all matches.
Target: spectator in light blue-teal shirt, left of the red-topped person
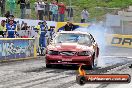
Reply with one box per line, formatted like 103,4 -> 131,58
51,2 -> 58,22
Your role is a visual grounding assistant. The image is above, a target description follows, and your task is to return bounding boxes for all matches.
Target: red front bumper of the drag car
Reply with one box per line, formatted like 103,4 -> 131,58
46,55 -> 93,65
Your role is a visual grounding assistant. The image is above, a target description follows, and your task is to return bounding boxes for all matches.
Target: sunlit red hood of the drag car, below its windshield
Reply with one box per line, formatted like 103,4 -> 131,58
48,43 -> 93,51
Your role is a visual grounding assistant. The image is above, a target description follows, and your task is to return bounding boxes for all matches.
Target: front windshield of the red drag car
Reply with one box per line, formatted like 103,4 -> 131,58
55,33 -> 91,45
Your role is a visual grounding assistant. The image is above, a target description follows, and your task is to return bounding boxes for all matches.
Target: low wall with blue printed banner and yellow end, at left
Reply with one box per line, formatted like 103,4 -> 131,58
0,38 -> 37,62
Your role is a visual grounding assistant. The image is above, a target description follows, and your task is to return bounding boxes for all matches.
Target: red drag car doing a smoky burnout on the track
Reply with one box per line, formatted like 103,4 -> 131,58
46,31 -> 99,69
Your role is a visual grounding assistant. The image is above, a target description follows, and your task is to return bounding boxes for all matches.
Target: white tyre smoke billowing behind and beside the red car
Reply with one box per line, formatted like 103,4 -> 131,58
75,22 -> 107,67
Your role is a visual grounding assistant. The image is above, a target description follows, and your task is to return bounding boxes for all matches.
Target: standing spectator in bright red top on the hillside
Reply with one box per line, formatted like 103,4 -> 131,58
58,2 -> 66,22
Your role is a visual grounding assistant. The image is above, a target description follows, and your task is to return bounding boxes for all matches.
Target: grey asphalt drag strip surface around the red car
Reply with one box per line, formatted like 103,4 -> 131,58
0,47 -> 132,88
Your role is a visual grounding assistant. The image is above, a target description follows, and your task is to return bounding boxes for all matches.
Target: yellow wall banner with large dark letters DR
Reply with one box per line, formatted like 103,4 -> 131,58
106,34 -> 132,48
